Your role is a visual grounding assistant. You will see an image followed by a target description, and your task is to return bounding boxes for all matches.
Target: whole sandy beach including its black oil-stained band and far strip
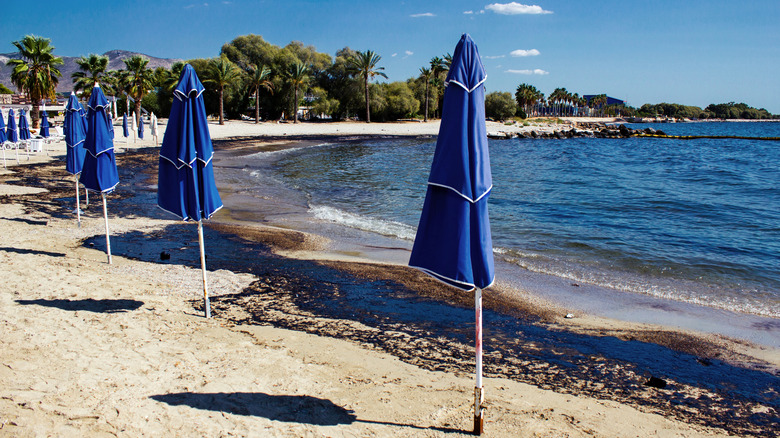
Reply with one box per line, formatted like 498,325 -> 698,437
0,119 -> 780,437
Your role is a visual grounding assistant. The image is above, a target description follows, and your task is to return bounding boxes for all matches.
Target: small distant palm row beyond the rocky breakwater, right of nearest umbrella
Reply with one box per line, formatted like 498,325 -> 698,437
515,84 -> 607,116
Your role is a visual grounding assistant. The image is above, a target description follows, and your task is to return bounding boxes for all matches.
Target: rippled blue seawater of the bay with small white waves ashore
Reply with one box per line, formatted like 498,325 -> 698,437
216,122 -> 780,318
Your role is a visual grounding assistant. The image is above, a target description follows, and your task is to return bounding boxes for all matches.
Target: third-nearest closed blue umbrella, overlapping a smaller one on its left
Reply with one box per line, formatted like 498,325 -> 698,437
80,84 -> 119,264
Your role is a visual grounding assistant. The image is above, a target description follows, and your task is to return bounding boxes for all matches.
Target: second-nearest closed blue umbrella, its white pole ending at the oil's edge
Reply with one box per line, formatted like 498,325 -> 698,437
157,64 -> 222,318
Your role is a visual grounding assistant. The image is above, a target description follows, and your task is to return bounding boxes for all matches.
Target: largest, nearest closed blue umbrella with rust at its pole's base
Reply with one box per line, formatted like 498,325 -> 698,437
409,34 -> 494,434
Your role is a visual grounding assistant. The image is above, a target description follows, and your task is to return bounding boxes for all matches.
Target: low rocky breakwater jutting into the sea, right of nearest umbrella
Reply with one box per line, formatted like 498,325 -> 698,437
488,122 -> 666,140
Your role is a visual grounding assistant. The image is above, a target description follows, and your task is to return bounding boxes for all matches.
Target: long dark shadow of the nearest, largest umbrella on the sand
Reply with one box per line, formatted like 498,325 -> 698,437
150,392 -> 464,433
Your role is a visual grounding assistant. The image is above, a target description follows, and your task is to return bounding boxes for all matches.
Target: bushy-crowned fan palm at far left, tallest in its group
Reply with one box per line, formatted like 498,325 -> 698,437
8,35 -> 63,128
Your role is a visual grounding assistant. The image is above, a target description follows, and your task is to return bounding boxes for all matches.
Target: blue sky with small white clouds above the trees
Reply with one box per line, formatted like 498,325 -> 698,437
0,0 -> 780,114
